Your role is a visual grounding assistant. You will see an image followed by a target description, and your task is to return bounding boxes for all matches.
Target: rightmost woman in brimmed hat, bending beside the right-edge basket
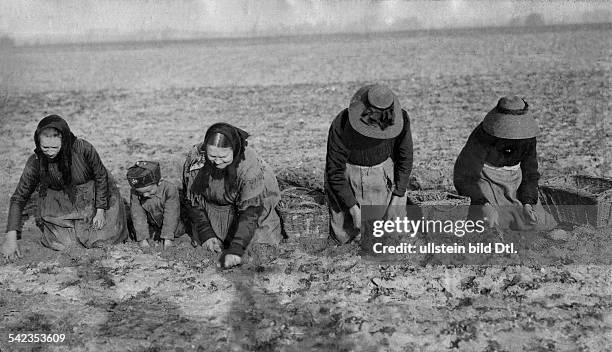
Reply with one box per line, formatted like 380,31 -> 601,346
453,96 -> 556,230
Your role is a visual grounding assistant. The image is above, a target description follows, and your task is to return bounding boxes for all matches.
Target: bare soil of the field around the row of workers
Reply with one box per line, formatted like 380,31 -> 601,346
0,27 -> 612,352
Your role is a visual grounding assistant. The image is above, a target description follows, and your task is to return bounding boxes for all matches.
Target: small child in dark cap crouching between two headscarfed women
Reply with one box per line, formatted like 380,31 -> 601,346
127,161 -> 185,249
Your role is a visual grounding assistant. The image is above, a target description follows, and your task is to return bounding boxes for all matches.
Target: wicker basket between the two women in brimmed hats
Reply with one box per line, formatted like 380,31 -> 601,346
407,190 -> 470,221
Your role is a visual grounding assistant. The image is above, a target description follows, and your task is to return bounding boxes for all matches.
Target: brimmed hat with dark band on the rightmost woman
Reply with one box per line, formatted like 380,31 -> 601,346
482,95 -> 539,139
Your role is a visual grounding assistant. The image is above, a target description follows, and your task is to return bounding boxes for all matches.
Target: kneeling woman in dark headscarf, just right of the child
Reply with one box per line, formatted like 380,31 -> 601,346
183,123 -> 282,267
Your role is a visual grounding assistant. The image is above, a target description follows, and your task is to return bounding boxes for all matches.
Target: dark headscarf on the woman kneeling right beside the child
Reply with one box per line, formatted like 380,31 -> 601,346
191,122 -> 249,195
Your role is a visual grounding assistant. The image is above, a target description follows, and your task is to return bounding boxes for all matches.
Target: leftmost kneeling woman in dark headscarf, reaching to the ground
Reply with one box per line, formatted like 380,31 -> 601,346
2,115 -> 128,257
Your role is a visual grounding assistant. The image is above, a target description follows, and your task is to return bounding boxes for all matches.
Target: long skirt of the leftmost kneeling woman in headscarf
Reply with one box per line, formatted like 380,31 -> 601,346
37,175 -> 128,250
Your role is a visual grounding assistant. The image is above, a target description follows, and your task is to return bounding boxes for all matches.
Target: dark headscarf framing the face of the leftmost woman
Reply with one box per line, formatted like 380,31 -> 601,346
34,115 -> 76,201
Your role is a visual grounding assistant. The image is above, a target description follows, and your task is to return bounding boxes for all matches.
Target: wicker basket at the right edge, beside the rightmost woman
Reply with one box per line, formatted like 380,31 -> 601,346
539,175 -> 612,227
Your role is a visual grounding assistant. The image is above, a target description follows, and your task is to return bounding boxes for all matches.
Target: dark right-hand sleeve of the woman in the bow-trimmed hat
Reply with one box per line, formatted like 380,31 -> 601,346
393,110 -> 413,197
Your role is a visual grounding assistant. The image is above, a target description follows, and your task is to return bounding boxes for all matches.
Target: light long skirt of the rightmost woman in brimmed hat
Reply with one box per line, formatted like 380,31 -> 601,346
470,164 -> 557,231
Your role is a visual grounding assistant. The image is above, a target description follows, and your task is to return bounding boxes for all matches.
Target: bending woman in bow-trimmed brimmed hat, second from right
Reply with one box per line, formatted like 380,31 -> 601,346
325,84 -> 412,244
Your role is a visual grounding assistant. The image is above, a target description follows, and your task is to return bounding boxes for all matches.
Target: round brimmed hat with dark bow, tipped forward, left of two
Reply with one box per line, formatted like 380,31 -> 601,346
348,84 -> 404,139
